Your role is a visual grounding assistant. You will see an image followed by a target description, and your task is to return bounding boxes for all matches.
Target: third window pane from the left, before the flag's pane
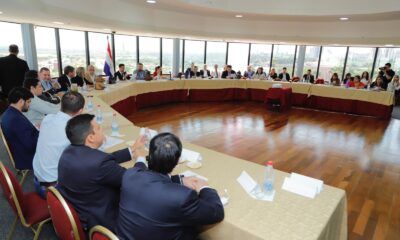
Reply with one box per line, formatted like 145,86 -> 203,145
60,29 -> 86,68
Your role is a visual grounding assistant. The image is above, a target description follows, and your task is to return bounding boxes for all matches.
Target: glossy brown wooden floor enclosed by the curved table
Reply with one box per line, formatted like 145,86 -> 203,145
128,102 -> 400,239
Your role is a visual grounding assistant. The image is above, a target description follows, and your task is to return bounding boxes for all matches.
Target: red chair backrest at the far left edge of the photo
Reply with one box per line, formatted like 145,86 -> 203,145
0,162 -> 26,224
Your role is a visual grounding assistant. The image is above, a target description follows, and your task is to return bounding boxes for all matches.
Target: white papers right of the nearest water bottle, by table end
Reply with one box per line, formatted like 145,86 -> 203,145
282,173 -> 324,198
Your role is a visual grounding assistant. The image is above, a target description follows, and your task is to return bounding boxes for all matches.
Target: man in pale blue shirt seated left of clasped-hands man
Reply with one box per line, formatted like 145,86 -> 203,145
33,92 -> 85,198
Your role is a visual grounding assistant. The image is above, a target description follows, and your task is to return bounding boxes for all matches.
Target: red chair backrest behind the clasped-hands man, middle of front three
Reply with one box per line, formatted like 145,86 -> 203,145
47,187 -> 85,240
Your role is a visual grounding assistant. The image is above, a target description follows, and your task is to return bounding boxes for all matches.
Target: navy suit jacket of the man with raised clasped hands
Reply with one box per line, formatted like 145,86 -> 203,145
57,145 -> 131,230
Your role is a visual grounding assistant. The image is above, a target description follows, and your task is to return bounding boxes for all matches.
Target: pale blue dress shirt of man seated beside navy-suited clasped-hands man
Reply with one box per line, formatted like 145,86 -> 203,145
33,112 -> 71,182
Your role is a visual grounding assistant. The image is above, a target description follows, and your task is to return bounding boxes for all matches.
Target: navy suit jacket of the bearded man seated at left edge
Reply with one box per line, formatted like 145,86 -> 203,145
1,106 -> 39,170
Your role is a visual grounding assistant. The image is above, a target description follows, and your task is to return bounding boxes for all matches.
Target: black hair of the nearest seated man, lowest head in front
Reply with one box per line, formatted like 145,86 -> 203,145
147,133 -> 182,174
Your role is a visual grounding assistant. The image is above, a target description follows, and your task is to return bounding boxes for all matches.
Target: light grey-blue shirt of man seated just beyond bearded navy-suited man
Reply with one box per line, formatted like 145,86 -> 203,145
24,96 -> 60,126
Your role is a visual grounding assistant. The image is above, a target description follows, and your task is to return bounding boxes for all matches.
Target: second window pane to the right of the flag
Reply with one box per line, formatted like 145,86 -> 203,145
139,37 -> 160,73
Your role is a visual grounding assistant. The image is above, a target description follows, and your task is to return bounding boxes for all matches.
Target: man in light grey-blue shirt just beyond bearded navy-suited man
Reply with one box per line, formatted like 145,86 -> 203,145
24,79 -> 60,125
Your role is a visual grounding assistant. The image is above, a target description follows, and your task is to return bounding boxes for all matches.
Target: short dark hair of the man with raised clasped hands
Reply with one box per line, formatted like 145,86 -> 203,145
65,114 -> 94,145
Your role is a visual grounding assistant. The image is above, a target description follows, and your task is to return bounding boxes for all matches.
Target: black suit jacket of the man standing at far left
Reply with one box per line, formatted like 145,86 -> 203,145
0,54 -> 29,97
